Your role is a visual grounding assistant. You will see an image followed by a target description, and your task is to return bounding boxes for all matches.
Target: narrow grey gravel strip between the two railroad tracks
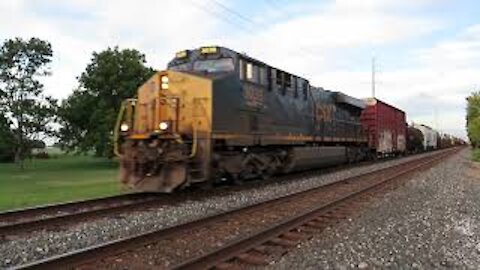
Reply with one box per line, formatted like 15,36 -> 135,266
0,151 -> 446,267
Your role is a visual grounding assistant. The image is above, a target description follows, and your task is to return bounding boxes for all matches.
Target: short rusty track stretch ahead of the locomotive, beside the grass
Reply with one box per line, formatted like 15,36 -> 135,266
0,193 -> 164,236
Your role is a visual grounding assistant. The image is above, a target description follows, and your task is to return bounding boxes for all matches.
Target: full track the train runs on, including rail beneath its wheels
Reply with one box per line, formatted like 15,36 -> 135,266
0,153 -> 402,239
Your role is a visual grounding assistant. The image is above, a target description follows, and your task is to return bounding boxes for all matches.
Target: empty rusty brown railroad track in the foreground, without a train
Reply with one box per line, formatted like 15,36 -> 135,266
13,149 -> 458,269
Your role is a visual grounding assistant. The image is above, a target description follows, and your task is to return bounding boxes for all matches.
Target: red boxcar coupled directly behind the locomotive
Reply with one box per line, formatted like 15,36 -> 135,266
360,98 -> 407,156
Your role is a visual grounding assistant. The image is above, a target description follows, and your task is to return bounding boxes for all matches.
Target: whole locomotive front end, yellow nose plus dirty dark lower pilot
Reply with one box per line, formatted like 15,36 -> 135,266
119,70 -> 212,192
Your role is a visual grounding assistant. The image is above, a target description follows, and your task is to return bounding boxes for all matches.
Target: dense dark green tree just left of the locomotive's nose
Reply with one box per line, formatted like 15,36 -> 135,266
59,47 -> 154,157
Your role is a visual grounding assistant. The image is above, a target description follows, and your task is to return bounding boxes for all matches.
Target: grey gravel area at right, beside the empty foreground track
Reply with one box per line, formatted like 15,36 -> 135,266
269,150 -> 480,269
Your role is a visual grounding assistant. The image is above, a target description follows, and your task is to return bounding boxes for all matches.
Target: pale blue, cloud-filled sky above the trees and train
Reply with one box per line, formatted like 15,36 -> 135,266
0,0 -> 480,137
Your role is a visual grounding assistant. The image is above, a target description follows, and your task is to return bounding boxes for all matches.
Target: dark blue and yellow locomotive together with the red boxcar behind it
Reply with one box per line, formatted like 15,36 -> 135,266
114,46 -> 464,192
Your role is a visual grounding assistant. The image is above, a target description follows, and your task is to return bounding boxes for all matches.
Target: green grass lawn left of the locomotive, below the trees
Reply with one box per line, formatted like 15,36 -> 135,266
0,155 -> 121,211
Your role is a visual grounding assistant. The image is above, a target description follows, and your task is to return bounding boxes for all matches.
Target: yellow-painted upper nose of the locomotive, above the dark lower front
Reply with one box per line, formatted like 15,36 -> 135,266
131,71 -> 212,138
